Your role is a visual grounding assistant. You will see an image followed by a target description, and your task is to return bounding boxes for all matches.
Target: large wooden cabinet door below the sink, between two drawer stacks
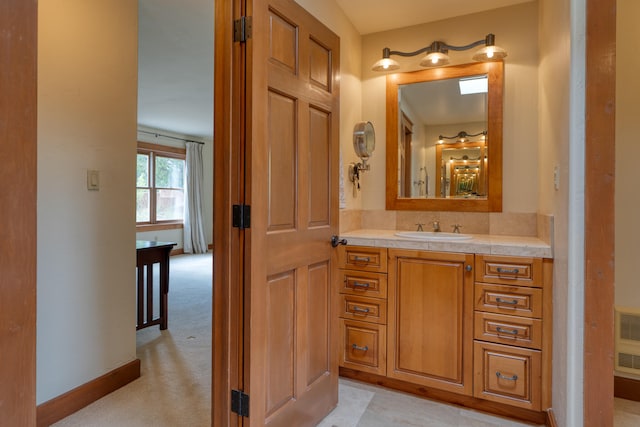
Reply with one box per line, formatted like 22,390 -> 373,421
387,250 -> 473,395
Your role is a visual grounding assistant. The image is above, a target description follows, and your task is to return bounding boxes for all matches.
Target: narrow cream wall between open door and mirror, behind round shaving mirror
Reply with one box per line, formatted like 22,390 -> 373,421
295,0 -> 362,210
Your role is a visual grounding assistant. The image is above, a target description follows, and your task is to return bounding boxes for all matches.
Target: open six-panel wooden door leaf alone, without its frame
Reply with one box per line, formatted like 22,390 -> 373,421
244,0 -> 339,426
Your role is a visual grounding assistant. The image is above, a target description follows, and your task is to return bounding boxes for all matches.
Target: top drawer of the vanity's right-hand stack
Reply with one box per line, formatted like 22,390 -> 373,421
476,255 -> 542,287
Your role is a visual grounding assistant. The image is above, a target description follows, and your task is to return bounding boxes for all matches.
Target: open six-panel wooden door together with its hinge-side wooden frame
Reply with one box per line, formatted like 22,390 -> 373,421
213,0 -> 340,426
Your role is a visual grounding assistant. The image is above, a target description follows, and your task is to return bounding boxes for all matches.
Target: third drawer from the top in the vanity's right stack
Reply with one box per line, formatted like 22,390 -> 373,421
474,311 -> 542,350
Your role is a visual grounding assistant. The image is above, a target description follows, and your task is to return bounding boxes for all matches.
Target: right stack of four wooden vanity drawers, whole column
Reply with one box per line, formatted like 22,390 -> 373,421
473,255 -> 552,411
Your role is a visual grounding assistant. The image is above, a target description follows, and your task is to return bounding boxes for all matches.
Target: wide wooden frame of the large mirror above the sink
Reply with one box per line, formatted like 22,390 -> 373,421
386,61 -> 504,212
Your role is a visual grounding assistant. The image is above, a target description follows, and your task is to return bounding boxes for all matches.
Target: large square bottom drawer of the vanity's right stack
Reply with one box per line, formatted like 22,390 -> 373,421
473,341 -> 541,411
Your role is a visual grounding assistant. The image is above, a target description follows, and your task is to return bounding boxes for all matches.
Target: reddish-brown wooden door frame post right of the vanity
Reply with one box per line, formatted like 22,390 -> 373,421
583,0 -> 616,427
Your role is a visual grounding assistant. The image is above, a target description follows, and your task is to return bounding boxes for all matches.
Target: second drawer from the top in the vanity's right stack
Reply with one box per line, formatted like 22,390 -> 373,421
475,283 -> 542,318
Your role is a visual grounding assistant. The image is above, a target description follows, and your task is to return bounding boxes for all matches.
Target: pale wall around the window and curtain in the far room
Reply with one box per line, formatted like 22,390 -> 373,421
136,126 -> 213,249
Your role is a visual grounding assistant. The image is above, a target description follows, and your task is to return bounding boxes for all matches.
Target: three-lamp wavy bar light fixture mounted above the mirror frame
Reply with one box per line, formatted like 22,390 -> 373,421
371,34 -> 507,71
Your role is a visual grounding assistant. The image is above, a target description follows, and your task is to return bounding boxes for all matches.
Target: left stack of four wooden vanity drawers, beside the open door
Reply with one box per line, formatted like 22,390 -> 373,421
336,246 -> 387,375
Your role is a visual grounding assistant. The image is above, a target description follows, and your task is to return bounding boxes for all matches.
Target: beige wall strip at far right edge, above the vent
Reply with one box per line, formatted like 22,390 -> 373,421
615,0 -> 640,309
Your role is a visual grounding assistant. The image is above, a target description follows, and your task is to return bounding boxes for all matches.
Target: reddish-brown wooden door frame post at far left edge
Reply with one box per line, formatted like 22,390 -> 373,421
0,0 -> 38,426
